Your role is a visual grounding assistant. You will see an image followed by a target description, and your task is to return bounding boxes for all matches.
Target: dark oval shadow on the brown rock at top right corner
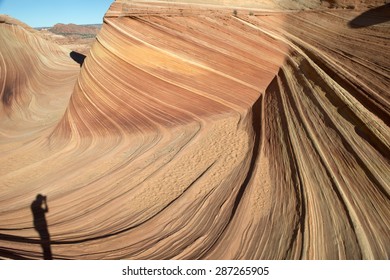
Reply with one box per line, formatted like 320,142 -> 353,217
348,4 -> 390,28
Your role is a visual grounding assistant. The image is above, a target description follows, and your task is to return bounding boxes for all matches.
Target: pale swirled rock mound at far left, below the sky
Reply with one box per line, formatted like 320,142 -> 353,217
0,16 -> 79,142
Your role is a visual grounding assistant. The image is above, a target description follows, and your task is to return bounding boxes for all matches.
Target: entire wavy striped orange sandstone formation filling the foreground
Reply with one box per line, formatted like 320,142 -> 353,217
0,1 -> 390,259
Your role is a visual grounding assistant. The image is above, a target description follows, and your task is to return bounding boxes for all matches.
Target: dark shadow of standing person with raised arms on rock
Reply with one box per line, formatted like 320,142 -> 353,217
31,194 -> 52,260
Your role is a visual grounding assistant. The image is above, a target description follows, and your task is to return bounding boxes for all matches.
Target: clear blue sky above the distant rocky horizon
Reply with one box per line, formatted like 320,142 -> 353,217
0,0 -> 114,27
